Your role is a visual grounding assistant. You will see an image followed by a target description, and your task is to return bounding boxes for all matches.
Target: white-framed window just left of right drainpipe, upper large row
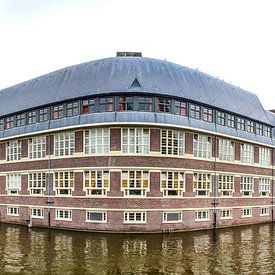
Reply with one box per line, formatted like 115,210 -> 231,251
193,134 -> 212,159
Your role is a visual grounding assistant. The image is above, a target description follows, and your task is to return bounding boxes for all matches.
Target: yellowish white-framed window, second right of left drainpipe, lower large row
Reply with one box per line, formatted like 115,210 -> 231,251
84,171 -> 110,196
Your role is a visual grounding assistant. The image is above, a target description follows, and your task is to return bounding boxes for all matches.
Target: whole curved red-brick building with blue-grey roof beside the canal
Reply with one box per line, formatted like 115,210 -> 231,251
0,53 -> 275,232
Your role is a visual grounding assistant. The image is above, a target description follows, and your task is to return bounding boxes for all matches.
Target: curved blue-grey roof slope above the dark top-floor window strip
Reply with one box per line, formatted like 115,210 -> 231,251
0,57 -> 270,124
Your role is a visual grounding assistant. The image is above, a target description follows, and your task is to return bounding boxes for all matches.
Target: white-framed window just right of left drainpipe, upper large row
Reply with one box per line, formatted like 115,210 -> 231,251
54,132 -> 75,157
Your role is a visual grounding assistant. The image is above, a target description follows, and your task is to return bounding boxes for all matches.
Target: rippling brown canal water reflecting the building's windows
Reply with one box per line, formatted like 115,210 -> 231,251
0,223 -> 275,275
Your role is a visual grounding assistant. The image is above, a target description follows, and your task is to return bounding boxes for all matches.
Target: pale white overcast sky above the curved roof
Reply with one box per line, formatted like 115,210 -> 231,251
0,0 -> 275,109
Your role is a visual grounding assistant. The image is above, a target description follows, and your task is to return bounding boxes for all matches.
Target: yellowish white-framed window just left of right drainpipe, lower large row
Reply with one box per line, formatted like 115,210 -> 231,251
193,173 -> 211,196
